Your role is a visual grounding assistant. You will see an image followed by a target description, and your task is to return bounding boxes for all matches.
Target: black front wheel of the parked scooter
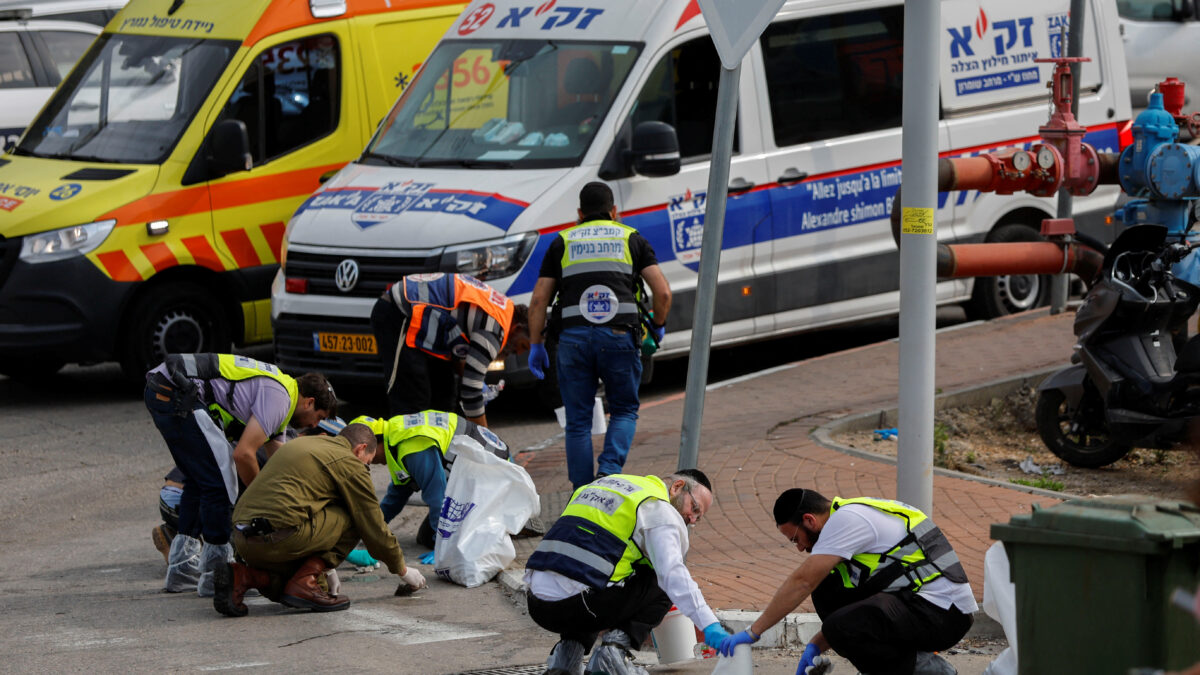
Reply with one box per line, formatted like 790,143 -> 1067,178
1037,387 -> 1130,468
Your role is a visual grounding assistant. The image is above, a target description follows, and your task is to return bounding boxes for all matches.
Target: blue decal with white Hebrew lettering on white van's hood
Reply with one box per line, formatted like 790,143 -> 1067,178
296,180 -> 529,232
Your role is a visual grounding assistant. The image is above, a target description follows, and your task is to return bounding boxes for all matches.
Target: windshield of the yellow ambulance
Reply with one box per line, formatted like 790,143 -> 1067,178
16,34 -> 238,163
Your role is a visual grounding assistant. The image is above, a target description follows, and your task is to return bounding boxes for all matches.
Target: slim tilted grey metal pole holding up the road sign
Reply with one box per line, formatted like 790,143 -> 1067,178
679,64 -> 742,468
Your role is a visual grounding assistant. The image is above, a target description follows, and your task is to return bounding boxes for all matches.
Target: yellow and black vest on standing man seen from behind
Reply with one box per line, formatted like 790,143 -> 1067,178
554,220 -> 638,328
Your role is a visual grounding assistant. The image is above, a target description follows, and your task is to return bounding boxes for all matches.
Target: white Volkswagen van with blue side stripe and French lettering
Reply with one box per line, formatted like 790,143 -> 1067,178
271,0 -> 1129,383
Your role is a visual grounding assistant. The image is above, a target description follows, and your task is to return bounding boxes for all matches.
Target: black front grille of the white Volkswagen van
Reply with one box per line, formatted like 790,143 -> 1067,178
284,251 -> 442,298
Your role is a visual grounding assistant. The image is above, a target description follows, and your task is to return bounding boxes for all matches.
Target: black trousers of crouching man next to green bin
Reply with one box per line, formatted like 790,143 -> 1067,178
812,574 -> 973,675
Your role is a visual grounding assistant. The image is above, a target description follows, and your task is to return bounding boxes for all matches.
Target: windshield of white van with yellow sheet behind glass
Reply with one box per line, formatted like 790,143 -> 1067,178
360,40 -> 641,168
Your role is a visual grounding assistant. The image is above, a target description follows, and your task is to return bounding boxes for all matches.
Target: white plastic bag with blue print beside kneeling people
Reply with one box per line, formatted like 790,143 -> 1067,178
433,436 -> 541,589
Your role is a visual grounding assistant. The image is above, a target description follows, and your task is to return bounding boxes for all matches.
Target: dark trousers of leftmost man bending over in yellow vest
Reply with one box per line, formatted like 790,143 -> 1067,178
145,383 -> 233,545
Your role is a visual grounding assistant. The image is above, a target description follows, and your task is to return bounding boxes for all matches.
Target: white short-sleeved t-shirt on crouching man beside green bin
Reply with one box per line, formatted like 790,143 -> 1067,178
812,504 -> 979,614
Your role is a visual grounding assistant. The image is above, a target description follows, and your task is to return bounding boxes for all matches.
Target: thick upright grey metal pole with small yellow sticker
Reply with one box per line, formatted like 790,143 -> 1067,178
896,0 -> 941,514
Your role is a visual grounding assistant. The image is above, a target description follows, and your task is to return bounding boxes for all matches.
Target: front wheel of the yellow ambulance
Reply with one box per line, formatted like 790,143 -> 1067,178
121,282 -> 232,380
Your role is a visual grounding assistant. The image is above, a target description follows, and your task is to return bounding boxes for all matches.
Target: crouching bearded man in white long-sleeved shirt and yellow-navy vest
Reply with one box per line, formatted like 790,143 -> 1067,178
524,468 -> 728,675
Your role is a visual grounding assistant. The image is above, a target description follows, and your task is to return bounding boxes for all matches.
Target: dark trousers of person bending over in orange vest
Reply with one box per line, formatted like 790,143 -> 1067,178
371,297 -> 458,416
